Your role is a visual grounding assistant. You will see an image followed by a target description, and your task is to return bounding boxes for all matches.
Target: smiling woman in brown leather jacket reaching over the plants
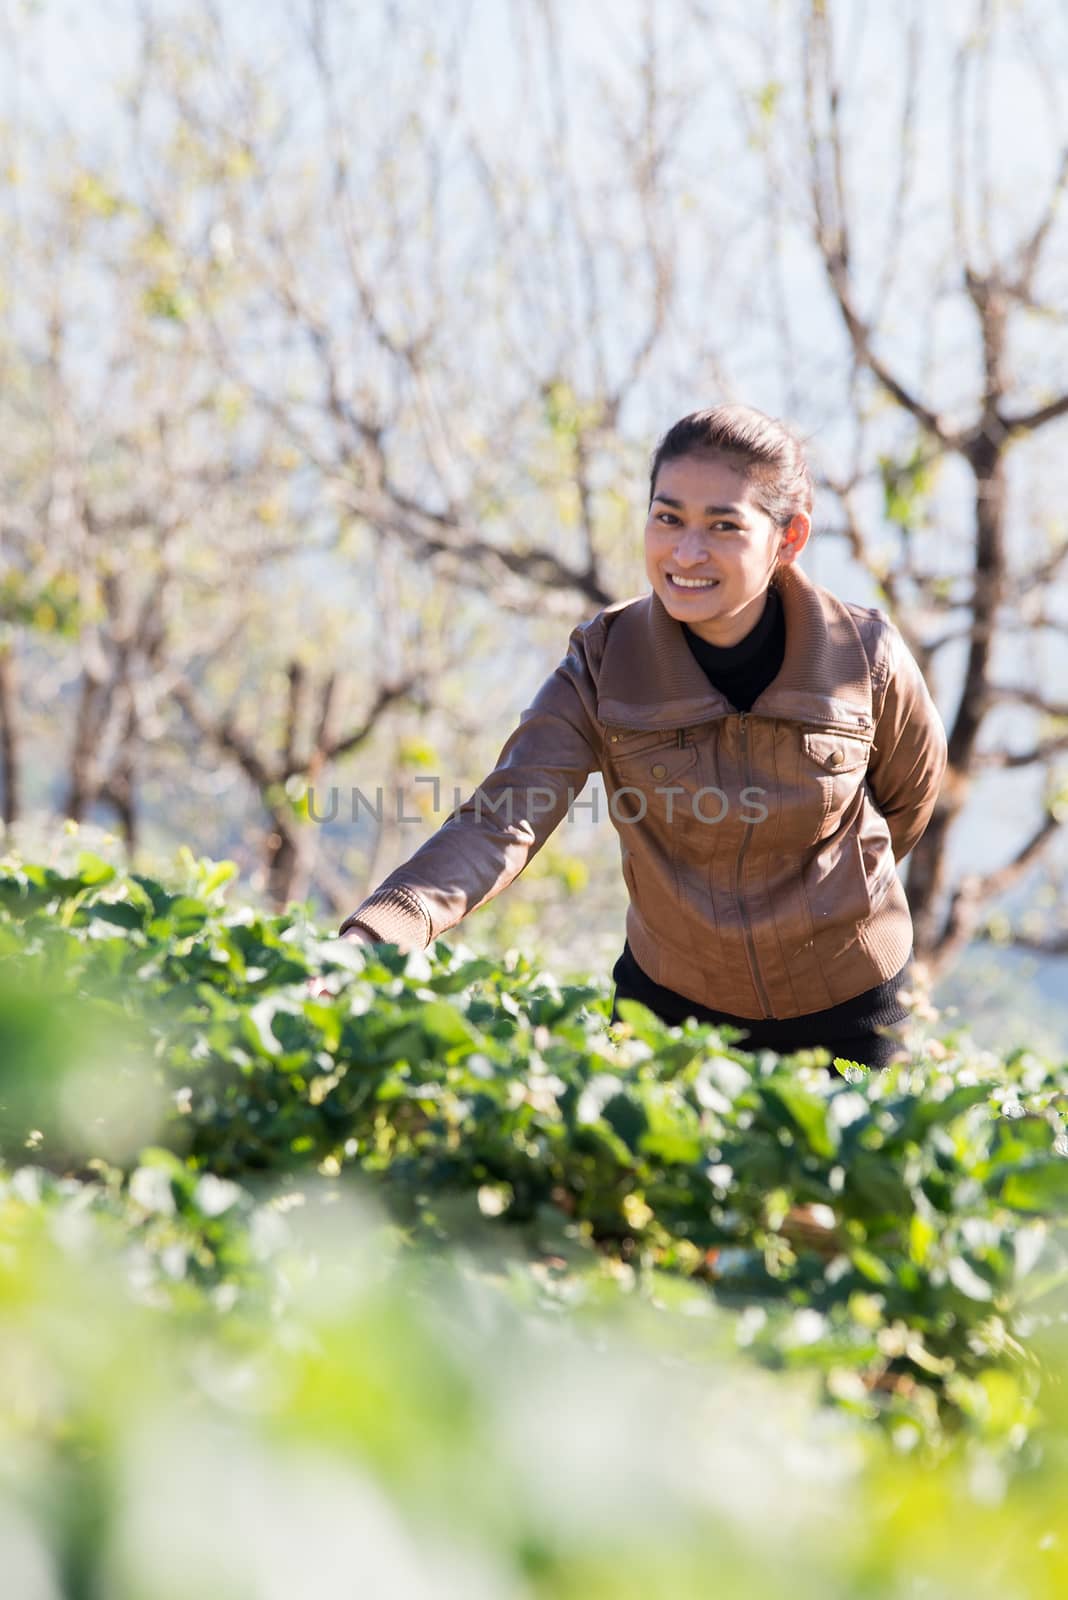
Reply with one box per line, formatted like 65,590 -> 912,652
341,405 -> 946,1067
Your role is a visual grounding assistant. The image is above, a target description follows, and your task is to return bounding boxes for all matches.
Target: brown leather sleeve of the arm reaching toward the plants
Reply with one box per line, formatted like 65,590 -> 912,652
339,619 -> 601,950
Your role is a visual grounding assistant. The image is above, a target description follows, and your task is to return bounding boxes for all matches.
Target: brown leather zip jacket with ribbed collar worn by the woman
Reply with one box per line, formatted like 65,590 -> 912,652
341,563 -> 946,1018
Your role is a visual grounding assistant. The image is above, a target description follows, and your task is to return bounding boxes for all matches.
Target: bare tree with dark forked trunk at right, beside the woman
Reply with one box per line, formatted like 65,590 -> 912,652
804,0 -> 1068,968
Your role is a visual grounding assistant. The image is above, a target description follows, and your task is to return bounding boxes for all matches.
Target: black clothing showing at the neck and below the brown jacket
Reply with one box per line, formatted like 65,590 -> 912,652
612,584 -> 911,1067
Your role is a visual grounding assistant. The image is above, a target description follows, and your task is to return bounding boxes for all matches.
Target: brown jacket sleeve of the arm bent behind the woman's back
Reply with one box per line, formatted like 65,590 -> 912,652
868,619 -> 946,861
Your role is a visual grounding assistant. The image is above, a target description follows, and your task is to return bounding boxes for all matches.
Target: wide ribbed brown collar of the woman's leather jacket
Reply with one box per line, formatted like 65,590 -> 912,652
596,562 -> 873,733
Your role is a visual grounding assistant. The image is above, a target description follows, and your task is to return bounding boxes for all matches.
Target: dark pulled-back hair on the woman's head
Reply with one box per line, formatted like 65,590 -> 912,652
649,405 -> 812,528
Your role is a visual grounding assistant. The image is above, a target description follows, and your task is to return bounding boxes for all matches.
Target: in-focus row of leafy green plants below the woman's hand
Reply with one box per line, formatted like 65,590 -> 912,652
0,853 -> 1068,1454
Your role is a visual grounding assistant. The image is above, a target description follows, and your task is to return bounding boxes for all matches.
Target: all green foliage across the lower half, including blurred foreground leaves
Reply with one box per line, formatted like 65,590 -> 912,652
0,850 -> 1068,1600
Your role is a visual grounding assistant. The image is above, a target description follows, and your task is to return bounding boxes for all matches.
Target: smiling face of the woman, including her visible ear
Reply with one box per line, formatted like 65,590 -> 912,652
646,454 -> 811,645
